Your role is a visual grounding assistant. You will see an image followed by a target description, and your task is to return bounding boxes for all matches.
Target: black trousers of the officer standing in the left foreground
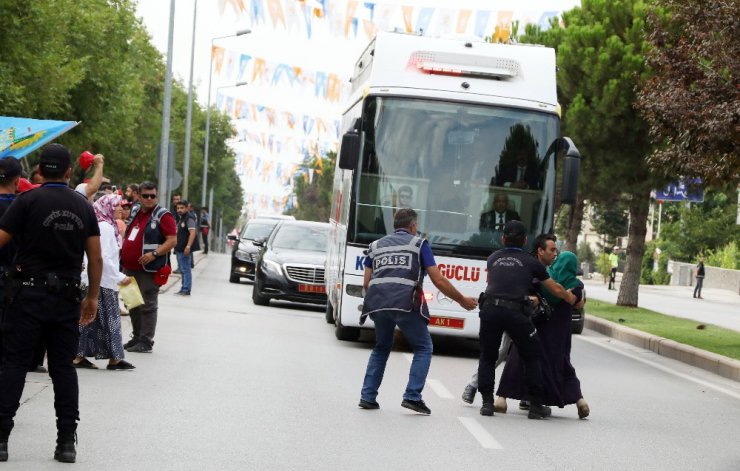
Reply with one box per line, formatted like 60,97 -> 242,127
0,287 -> 80,429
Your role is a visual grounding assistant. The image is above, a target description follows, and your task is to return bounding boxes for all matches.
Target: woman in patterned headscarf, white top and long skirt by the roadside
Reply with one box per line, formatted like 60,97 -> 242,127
74,193 -> 134,370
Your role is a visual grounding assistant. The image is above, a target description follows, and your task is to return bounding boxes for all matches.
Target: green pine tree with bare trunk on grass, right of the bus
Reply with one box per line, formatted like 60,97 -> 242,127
525,0 -> 662,306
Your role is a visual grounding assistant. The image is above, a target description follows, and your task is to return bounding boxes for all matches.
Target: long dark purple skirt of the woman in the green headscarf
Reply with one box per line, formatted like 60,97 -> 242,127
496,302 -> 583,407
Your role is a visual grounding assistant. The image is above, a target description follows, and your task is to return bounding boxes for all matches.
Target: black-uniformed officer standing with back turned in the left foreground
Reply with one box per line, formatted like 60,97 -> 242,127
0,144 -> 103,463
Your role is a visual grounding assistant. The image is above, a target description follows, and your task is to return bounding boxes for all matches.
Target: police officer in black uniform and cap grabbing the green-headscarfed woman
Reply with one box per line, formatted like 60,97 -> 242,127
478,221 -> 576,419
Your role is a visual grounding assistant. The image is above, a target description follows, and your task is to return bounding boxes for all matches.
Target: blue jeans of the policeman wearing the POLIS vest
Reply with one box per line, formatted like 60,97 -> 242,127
360,311 -> 433,402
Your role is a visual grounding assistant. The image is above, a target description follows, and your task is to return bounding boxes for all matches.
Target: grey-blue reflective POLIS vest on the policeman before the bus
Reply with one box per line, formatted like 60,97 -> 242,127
360,232 -> 429,323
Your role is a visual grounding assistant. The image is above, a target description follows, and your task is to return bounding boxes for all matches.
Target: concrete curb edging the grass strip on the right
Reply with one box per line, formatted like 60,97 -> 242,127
585,315 -> 740,381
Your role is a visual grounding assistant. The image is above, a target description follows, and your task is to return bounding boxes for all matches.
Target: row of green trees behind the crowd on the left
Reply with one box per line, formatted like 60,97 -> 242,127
0,0 -> 242,235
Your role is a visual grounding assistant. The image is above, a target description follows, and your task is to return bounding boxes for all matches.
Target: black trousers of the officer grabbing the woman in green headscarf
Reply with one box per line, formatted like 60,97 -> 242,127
478,304 -> 543,405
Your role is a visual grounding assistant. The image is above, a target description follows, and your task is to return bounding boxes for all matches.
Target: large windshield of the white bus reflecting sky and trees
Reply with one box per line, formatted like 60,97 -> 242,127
348,97 -> 559,257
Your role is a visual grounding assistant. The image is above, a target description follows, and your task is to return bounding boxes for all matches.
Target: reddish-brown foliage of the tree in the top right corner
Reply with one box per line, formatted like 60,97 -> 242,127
638,0 -> 740,185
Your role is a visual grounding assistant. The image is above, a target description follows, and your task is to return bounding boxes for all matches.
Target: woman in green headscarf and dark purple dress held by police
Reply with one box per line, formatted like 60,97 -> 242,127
496,252 -> 590,419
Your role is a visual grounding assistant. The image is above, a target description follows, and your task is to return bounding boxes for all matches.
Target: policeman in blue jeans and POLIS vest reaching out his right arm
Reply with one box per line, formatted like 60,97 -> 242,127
359,208 -> 478,415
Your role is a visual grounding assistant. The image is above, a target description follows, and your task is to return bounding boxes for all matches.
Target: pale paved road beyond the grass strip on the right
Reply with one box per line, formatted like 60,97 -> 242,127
583,275 -> 740,332
